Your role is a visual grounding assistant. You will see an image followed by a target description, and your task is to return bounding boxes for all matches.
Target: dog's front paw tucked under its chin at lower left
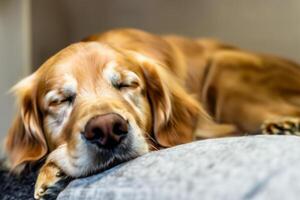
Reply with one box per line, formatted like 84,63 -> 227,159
34,163 -> 71,200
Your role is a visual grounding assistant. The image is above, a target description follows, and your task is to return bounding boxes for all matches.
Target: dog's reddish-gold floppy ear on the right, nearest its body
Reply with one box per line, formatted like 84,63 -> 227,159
136,54 -> 209,147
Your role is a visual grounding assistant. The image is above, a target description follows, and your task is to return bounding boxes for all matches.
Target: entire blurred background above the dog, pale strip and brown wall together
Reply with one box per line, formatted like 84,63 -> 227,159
0,0 -> 300,144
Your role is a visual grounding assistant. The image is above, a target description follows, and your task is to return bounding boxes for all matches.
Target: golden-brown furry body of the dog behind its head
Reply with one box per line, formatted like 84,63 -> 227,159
88,30 -> 300,138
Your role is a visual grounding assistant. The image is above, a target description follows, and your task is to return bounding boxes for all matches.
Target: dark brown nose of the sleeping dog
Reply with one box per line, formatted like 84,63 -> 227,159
83,113 -> 128,149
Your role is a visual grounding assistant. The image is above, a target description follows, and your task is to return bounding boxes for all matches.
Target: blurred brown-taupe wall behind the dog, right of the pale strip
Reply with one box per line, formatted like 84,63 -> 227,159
33,0 -> 300,66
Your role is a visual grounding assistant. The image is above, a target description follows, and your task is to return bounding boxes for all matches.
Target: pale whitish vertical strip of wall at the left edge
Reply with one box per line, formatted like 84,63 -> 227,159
0,0 -> 30,144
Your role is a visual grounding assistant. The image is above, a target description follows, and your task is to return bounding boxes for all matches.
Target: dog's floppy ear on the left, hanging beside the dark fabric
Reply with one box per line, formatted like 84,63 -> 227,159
5,74 -> 47,172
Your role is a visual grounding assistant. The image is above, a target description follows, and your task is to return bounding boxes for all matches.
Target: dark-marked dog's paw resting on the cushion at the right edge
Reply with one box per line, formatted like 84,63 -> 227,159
261,117 -> 300,136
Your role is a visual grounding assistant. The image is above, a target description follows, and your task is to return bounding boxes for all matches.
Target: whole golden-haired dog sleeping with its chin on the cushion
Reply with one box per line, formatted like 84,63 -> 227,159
6,29 -> 300,199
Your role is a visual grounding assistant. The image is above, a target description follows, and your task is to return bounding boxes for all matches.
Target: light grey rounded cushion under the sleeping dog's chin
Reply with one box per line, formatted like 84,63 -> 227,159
58,136 -> 300,200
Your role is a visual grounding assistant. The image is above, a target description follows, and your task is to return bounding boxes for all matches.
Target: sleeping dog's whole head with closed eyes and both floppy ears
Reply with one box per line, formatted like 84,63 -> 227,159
6,42 -> 204,177
